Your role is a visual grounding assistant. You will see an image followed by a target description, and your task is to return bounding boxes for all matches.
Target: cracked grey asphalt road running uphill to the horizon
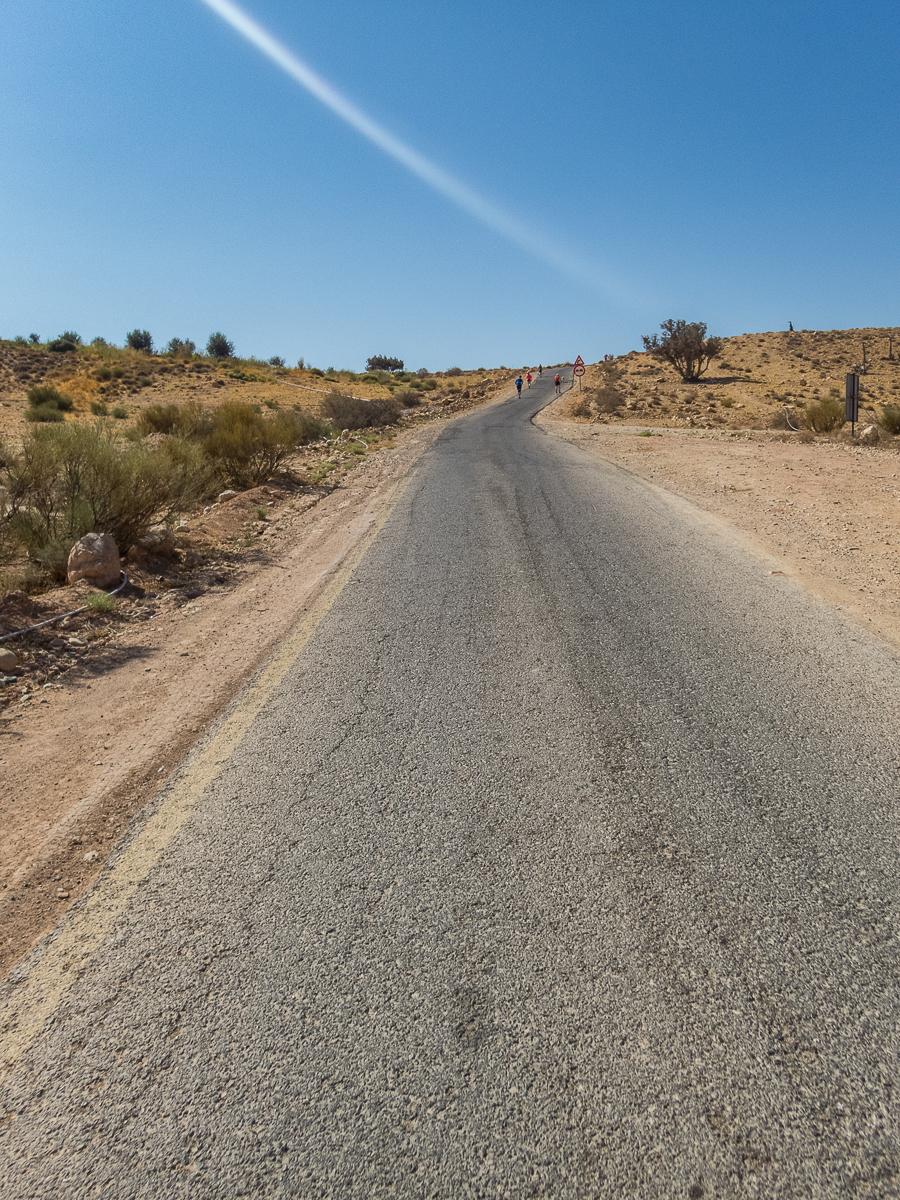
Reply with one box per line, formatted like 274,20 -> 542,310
0,378 -> 900,1200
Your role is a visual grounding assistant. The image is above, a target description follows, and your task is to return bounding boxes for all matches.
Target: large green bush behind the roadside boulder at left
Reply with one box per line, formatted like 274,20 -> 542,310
2,421 -> 212,571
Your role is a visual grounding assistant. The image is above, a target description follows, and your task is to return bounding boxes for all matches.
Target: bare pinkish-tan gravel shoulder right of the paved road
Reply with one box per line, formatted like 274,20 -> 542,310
535,392 -> 900,650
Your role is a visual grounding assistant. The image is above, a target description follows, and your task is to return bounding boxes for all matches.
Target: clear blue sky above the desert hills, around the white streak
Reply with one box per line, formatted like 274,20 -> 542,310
0,0 -> 900,370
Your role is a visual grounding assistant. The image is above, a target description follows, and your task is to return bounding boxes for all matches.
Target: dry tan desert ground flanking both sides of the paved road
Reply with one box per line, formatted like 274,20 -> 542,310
0,330 -> 900,970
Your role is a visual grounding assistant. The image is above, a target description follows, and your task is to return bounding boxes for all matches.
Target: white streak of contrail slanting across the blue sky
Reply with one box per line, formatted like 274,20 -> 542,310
196,0 -> 619,292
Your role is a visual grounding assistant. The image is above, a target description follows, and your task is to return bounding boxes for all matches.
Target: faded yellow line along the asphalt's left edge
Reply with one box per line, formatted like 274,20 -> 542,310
0,475 -> 412,1081
